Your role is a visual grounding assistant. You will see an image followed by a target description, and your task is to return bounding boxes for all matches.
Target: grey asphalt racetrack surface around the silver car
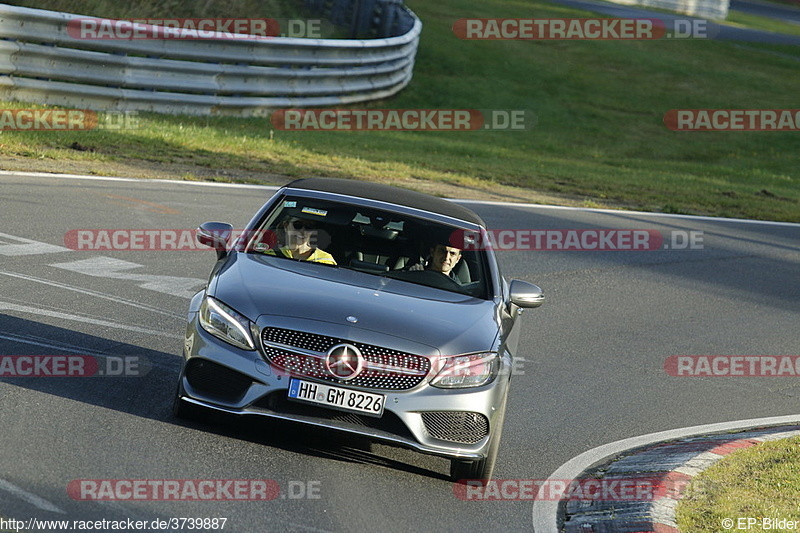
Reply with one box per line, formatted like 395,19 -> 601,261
0,175 -> 800,533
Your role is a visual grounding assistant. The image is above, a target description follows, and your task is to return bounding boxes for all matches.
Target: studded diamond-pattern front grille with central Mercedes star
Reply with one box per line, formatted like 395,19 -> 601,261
261,327 -> 431,390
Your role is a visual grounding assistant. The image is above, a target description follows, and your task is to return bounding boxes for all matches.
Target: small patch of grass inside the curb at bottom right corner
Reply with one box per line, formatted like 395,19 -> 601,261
677,437 -> 800,533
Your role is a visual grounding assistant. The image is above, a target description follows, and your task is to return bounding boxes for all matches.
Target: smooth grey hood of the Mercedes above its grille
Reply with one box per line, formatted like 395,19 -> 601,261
209,254 -> 498,355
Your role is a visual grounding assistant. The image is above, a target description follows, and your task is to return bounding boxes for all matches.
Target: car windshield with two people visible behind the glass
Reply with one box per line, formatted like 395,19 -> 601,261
246,196 -> 491,299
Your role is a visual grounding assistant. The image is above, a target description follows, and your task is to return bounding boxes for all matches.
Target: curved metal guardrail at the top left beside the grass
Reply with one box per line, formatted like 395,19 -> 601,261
0,0 -> 422,116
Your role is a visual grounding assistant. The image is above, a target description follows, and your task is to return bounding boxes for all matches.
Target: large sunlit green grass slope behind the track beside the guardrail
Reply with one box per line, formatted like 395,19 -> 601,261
0,0 -> 800,222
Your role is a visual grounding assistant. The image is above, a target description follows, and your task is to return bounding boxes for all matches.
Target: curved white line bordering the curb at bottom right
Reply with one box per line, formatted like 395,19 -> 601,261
532,415 -> 800,533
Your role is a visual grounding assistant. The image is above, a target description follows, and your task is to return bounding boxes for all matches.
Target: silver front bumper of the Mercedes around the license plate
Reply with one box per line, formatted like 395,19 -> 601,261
178,314 -> 511,460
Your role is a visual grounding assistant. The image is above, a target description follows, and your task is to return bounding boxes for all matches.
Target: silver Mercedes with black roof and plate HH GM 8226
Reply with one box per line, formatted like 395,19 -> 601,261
174,179 -> 544,480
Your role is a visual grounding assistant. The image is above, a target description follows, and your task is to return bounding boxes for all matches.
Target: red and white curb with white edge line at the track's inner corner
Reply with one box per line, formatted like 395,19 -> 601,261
532,415 -> 800,533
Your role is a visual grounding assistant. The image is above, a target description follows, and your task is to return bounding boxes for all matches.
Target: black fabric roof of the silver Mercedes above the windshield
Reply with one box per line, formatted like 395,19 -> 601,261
286,178 -> 486,226
